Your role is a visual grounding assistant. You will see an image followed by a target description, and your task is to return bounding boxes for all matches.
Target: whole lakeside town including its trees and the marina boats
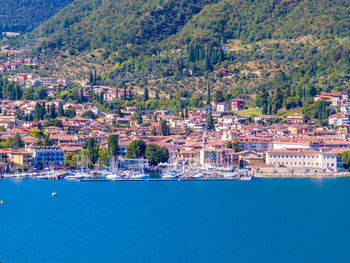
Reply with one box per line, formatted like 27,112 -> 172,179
0,46 -> 350,178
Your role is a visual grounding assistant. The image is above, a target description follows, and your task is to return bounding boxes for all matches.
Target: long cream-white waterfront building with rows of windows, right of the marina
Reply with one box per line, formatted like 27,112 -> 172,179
266,149 -> 338,172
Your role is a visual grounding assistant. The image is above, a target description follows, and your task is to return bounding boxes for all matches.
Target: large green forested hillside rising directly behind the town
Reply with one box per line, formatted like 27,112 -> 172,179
28,0 -> 350,107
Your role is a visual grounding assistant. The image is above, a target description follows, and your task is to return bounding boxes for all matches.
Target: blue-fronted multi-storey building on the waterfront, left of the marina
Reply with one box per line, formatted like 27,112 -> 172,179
26,145 -> 65,168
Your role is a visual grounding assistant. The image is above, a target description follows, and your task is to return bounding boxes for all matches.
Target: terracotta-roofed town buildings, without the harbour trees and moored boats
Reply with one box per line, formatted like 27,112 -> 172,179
0,47 -> 350,178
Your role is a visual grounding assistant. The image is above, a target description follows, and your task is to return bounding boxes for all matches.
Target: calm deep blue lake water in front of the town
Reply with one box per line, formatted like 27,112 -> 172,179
0,178 -> 350,263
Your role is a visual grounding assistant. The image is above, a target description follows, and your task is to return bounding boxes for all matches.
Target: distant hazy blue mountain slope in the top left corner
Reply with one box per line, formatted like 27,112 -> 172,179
0,0 -> 73,32
